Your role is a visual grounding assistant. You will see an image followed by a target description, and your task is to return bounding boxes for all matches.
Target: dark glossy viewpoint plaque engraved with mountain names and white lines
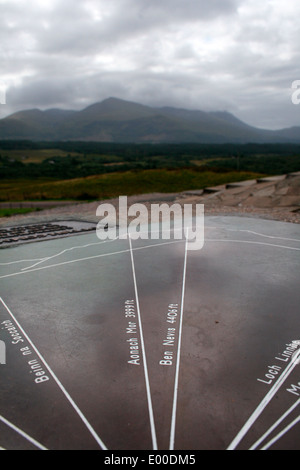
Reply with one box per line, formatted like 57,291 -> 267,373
0,217 -> 300,450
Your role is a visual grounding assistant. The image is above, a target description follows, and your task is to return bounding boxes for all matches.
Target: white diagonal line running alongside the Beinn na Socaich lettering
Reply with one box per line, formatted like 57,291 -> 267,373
0,297 -> 107,450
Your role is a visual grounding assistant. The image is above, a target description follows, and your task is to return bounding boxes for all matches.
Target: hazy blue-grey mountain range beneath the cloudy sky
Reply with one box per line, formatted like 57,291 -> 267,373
0,98 -> 300,144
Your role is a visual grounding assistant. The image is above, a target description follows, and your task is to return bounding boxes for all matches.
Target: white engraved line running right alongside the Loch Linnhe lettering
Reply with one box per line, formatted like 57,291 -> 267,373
227,349 -> 300,450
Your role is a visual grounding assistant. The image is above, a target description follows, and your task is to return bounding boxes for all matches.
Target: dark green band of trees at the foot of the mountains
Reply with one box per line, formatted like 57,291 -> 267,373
0,141 -> 300,179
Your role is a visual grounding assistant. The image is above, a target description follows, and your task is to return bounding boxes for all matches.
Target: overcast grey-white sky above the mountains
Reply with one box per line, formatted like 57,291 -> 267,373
0,0 -> 300,129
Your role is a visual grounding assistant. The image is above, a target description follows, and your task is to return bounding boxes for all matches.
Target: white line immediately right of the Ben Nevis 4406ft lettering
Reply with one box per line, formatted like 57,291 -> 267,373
169,229 -> 188,450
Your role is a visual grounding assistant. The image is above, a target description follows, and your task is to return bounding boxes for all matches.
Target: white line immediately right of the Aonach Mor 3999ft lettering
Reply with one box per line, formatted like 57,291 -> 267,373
128,235 -> 157,450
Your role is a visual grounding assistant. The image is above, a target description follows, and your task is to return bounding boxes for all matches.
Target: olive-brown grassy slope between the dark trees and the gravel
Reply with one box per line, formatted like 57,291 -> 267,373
0,169 -> 262,201
